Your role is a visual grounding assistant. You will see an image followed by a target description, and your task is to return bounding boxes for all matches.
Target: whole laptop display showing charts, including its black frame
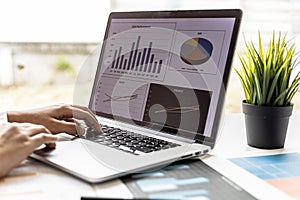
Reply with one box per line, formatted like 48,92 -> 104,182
90,10 -> 241,147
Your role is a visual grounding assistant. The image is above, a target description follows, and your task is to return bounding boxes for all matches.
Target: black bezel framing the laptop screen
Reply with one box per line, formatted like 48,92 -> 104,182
89,9 -> 242,148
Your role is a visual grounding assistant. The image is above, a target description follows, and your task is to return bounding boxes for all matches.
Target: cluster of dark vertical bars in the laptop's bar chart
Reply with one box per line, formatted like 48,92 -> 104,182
111,36 -> 163,74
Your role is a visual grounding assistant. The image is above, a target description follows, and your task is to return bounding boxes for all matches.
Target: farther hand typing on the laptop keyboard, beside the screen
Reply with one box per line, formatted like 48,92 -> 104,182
8,104 -> 101,135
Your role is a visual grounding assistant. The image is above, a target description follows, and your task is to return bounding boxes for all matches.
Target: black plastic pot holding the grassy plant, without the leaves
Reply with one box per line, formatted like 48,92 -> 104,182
243,101 -> 293,149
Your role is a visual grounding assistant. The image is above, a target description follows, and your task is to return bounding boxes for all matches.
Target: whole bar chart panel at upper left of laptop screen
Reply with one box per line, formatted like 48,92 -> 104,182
104,24 -> 173,80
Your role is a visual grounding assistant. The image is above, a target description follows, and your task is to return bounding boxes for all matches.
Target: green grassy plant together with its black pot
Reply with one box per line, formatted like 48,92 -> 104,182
235,33 -> 300,149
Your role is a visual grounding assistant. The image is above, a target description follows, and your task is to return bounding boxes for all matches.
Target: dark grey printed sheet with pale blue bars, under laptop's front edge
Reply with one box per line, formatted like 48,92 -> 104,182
122,159 -> 255,200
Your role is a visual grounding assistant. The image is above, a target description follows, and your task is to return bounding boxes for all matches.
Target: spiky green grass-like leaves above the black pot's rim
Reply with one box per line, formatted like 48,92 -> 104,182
235,33 -> 300,106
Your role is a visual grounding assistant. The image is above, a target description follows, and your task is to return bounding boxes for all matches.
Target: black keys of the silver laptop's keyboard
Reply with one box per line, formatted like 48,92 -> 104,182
84,125 -> 180,155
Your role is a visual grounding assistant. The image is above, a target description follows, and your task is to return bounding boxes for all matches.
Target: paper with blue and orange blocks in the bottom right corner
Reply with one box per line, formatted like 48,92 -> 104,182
230,153 -> 300,198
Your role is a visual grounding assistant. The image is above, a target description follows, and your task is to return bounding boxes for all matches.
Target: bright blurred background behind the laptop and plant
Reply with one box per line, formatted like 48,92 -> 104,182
0,0 -> 300,112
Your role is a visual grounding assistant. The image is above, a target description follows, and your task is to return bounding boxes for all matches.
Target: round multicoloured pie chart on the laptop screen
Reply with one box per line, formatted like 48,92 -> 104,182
180,38 -> 213,65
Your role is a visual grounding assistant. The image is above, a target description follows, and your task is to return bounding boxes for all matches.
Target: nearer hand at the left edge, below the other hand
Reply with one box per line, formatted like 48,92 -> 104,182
0,123 -> 57,177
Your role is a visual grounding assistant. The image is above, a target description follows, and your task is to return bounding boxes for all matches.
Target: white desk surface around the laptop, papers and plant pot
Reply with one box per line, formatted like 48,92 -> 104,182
0,111 -> 300,200
